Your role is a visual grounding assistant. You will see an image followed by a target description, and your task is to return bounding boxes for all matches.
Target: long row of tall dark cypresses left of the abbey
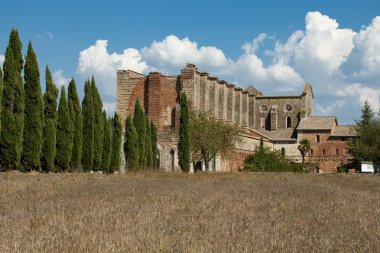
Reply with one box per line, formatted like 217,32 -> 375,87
0,29 -> 122,172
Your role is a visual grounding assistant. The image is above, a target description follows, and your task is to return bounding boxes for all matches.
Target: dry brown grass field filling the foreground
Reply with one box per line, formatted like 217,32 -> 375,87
0,172 -> 380,252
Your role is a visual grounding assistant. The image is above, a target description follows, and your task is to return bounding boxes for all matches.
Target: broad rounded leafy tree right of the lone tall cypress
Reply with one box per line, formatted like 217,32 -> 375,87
190,112 -> 242,170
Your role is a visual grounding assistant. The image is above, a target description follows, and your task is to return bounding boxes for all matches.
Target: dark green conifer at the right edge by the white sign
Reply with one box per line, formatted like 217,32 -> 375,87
350,101 -> 380,165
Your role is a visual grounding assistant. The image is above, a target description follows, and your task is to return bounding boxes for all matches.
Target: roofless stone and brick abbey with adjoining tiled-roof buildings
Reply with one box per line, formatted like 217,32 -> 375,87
116,64 -> 353,172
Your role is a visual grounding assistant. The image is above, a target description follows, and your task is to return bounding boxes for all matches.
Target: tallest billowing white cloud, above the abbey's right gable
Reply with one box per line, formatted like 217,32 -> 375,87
275,12 -> 356,76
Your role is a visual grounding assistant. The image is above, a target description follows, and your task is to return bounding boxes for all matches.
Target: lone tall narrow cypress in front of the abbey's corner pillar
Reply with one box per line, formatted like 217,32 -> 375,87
178,93 -> 190,172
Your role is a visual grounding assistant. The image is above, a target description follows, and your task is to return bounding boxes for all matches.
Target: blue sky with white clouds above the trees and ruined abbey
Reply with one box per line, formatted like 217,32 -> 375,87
0,0 -> 380,123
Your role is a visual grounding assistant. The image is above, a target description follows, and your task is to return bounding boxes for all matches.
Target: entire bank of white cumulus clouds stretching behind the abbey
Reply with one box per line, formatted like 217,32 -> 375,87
78,12 -> 380,121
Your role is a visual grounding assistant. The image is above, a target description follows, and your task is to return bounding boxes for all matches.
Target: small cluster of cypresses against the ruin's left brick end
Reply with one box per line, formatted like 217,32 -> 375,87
124,99 -> 157,170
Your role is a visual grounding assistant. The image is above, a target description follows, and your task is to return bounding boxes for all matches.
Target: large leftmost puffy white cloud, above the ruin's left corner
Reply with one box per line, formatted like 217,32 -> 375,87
78,40 -> 148,95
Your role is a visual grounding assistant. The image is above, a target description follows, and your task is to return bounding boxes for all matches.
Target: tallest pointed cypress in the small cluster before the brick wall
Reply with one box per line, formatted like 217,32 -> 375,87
133,99 -> 146,168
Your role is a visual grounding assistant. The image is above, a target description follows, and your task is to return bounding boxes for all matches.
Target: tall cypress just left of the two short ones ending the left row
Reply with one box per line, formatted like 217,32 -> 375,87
91,77 -> 104,170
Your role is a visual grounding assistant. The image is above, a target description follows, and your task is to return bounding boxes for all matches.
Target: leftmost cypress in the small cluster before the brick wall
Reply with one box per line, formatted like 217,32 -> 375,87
124,116 -> 139,170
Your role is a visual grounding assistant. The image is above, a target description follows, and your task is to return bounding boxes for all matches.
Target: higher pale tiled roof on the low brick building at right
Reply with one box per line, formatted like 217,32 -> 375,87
297,116 -> 337,130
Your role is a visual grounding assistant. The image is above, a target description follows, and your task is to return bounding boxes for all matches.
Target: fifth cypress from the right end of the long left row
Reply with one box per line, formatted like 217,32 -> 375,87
68,79 -> 83,171
